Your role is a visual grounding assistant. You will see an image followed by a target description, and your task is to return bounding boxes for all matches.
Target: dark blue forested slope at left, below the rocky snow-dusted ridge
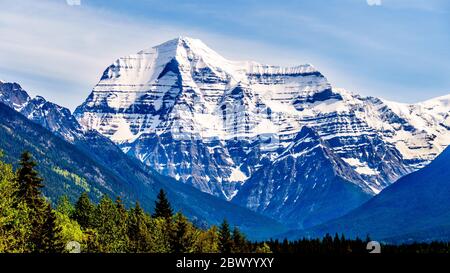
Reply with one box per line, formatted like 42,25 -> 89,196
0,85 -> 284,238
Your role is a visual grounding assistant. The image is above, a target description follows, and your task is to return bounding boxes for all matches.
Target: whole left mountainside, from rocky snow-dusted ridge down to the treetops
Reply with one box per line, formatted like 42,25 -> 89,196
0,79 -> 286,237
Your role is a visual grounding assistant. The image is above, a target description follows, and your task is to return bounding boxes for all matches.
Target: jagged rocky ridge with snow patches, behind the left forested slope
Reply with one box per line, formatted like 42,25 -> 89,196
0,82 -> 158,188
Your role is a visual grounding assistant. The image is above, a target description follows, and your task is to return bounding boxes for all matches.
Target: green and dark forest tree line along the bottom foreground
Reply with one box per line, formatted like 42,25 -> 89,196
0,151 -> 450,254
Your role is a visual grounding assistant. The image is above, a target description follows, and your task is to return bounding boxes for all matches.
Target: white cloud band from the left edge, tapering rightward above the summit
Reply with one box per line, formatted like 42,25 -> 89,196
0,0 -> 330,109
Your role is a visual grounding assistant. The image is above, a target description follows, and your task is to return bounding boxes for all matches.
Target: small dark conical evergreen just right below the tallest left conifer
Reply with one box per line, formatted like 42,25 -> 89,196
36,204 -> 65,253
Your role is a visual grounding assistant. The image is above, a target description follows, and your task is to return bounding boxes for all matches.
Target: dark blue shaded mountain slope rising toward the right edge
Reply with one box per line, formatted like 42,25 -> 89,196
290,148 -> 450,242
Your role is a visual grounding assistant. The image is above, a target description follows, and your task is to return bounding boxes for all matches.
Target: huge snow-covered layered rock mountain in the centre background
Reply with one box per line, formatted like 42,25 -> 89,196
75,37 -> 450,228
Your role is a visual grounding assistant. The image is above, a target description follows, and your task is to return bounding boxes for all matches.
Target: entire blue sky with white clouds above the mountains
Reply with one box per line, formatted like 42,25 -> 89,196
0,0 -> 450,110
